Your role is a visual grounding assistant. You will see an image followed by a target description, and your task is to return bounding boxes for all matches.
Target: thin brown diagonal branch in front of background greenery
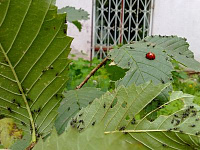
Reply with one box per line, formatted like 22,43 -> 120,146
76,57 -> 109,89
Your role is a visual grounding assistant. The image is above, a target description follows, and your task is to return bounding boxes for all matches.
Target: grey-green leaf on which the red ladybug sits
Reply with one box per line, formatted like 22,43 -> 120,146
110,42 -> 173,86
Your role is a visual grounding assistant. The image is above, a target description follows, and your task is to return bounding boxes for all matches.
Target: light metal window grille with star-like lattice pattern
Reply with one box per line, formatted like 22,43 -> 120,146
92,0 -> 153,59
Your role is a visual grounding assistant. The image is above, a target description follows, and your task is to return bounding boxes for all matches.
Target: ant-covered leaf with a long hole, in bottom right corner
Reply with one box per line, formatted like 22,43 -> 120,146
110,92 -> 200,150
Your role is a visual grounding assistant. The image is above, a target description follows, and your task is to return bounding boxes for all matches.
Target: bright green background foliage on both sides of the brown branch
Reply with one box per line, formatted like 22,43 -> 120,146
66,58 -> 126,91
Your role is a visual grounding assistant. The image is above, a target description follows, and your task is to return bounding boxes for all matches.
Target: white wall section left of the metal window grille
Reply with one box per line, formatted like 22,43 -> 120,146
56,0 -> 92,58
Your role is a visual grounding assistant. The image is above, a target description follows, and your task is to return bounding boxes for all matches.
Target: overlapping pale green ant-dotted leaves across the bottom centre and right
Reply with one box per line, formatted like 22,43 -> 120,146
34,83 -> 200,150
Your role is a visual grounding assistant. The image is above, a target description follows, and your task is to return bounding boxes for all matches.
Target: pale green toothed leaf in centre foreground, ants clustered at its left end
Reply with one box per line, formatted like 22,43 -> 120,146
69,82 -> 169,131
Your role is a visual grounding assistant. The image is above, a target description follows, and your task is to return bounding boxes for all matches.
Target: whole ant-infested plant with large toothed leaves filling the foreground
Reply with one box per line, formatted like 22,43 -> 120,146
0,0 -> 200,150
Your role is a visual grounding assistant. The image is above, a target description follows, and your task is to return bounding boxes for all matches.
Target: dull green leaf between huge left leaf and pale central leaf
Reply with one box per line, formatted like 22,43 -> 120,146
55,88 -> 104,134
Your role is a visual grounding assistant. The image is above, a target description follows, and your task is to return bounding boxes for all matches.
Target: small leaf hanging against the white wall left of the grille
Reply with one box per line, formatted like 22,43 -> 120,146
58,6 -> 89,31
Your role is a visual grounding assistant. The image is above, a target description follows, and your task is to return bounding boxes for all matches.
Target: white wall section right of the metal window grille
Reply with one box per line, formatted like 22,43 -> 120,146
152,0 -> 200,61
